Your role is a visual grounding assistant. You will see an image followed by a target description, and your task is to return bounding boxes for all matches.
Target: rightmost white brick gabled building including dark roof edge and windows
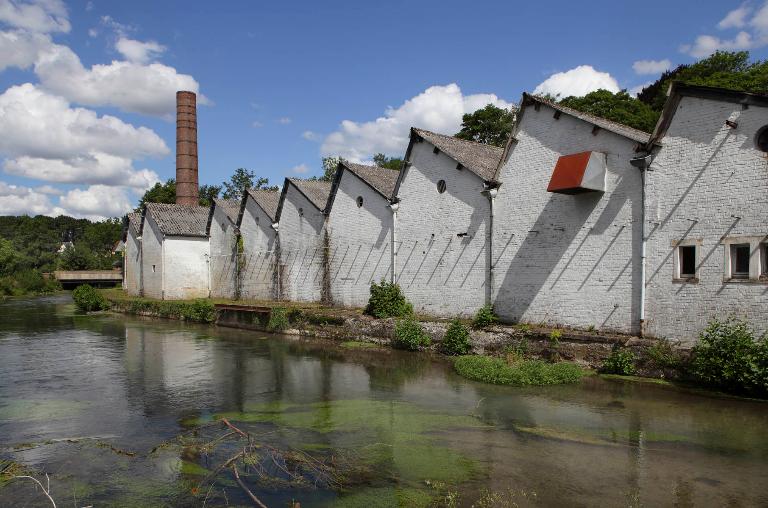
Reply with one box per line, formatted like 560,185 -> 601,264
645,83 -> 768,341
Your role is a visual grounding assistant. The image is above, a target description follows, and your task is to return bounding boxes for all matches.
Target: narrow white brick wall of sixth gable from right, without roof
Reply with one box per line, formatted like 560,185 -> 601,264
240,196 -> 277,300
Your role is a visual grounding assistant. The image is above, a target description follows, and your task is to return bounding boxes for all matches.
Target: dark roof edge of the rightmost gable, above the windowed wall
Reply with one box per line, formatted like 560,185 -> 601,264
647,81 -> 768,149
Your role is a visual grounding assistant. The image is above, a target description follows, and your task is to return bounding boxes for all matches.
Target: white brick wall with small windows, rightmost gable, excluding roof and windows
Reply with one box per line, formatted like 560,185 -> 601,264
646,97 -> 768,343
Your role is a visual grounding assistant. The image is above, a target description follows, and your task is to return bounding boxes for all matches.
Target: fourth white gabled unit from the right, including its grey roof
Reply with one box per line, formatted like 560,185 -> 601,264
326,161 -> 399,307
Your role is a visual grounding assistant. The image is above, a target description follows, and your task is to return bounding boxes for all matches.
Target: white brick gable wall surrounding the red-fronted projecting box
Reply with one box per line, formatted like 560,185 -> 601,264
493,105 -> 642,332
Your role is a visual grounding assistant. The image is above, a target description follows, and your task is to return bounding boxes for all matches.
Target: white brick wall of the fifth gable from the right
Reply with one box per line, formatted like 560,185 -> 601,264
279,184 -> 325,302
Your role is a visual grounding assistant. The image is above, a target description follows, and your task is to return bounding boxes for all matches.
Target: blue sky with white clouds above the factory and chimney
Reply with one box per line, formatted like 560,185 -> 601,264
0,0 -> 768,218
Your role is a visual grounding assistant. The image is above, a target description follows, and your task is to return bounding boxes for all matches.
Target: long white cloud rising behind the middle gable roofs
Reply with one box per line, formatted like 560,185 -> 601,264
320,83 -> 513,161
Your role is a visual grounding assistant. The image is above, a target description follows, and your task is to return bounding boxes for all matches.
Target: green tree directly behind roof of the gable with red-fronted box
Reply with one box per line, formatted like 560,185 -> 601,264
560,90 -> 659,132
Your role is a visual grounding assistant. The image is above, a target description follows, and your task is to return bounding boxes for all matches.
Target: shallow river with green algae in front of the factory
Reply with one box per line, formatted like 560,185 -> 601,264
0,294 -> 768,507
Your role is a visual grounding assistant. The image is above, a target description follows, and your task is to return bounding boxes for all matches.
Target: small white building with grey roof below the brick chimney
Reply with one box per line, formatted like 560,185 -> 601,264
140,203 -> 210,300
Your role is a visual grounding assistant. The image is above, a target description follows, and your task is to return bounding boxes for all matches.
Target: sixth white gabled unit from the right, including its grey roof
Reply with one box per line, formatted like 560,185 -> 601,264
238,189 -> 280,300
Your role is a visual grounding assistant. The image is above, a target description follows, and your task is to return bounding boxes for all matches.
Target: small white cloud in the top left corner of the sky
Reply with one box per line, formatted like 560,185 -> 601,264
0,0 -> 71,33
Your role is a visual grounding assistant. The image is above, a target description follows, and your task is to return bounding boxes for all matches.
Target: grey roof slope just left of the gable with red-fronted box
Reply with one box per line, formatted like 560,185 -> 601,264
411,127 -> 504,182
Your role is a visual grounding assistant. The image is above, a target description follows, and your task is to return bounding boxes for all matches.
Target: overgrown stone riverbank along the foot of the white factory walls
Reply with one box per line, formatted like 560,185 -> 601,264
101,289 -> 689,379
